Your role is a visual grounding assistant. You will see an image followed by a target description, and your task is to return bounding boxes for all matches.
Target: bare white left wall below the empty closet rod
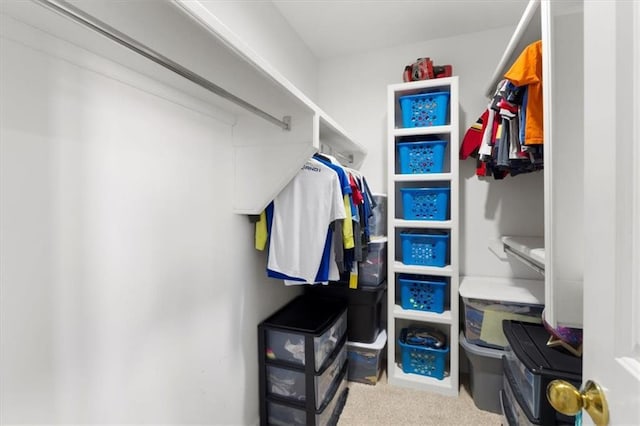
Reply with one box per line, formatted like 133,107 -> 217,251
0,7 -> 294,424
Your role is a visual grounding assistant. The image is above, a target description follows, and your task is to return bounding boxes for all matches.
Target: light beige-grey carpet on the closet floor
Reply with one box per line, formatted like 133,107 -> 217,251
338,373 -> 502,426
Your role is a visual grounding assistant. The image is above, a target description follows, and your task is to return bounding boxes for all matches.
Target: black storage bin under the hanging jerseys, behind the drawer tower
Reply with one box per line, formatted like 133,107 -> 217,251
306,281 -> 387,343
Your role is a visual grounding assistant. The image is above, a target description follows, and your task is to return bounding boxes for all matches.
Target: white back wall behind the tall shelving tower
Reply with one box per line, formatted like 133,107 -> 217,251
318,27 -> 544,278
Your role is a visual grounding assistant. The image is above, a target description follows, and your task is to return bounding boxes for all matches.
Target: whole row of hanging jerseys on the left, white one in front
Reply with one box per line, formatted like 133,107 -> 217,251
255,154 -> 375,285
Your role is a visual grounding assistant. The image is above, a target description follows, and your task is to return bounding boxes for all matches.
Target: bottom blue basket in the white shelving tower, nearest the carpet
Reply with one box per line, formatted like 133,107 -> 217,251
398,328 -> 449,380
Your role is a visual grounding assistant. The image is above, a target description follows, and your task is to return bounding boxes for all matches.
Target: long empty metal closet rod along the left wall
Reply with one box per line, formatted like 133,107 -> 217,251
33,0 -> 291,130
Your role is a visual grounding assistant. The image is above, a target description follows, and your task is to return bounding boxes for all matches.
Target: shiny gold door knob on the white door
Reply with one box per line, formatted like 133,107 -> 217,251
547,380 -> 609,426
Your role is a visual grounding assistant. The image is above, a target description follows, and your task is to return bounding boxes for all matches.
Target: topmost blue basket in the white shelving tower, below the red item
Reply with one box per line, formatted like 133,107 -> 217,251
399,92 -> 449,127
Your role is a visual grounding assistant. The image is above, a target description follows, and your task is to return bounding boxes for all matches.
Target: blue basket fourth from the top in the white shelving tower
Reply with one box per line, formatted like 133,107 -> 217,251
400,233 -> 449,266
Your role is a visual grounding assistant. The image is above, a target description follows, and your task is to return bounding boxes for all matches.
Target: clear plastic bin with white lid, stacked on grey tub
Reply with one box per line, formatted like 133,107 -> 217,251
459,277 -> 544,349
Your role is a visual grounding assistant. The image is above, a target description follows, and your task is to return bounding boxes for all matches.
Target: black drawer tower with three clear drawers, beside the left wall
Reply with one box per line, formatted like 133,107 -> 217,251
258,295 -> 347,425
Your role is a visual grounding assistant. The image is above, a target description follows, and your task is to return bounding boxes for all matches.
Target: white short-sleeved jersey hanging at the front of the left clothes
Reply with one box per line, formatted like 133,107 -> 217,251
267,159 -> 346,283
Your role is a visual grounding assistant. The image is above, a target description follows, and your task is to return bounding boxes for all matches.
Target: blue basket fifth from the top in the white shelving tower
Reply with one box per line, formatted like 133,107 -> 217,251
398,277 -> 447,314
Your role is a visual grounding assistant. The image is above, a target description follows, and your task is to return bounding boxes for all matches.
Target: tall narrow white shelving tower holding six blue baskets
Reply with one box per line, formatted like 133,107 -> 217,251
387,77 -> 459,396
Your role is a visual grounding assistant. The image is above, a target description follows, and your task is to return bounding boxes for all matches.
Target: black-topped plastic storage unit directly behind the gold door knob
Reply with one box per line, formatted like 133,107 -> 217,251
502,321 -> 582,425
